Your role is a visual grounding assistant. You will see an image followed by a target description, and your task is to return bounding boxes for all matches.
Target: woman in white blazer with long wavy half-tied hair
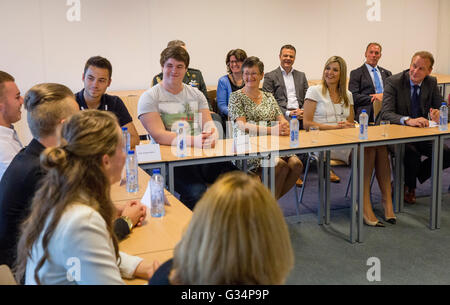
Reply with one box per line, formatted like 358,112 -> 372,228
16,110 -> 153,284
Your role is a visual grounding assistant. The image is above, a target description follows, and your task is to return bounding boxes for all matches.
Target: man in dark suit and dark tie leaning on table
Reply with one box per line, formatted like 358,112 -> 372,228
377,51 -> 450,203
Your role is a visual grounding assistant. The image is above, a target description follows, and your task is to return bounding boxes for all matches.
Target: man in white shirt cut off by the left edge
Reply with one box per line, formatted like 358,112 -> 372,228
0,71 -> 23,179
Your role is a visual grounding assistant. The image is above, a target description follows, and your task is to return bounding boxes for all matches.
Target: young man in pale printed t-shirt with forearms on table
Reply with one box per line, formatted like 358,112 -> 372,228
138,46 -> 236,209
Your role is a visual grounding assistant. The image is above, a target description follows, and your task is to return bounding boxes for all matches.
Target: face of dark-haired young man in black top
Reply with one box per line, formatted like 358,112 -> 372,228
83,66 -> 111,99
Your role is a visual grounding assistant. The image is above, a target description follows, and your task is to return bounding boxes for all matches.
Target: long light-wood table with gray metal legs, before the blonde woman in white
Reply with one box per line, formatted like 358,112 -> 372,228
140,124 -> 450,243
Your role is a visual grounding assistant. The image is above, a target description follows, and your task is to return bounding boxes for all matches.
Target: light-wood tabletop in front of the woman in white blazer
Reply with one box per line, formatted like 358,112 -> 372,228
111,169 -> 192,285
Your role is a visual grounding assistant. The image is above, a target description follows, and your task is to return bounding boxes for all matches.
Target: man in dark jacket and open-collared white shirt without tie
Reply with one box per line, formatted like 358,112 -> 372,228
263,45 -> 308,120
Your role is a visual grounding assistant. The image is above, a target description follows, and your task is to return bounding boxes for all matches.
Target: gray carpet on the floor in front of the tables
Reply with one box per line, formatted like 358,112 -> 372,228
280,179 -> 450,285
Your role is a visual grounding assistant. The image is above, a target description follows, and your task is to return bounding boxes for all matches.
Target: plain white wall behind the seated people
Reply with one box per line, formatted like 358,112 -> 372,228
0,0 -> 450,143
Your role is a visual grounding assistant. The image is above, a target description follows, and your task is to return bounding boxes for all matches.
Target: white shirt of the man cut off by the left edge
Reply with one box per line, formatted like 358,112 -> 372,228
0,126 -> 23,180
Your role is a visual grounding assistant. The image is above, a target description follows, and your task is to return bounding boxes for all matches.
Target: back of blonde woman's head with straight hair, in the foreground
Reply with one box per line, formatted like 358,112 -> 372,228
150,172 -> 294,285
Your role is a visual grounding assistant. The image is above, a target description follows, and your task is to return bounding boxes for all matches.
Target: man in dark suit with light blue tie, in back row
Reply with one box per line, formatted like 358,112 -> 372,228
348,42 -> 392,122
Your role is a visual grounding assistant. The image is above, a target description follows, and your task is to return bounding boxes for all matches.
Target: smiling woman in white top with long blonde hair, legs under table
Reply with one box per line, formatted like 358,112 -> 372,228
303,56 -> 396,227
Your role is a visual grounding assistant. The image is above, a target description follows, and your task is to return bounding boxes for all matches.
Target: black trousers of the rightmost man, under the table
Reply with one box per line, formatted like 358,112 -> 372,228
404,141 -> 450,189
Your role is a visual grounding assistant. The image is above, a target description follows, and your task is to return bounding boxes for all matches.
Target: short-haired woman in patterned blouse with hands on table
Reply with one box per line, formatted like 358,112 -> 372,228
228,56 -> 303,199
